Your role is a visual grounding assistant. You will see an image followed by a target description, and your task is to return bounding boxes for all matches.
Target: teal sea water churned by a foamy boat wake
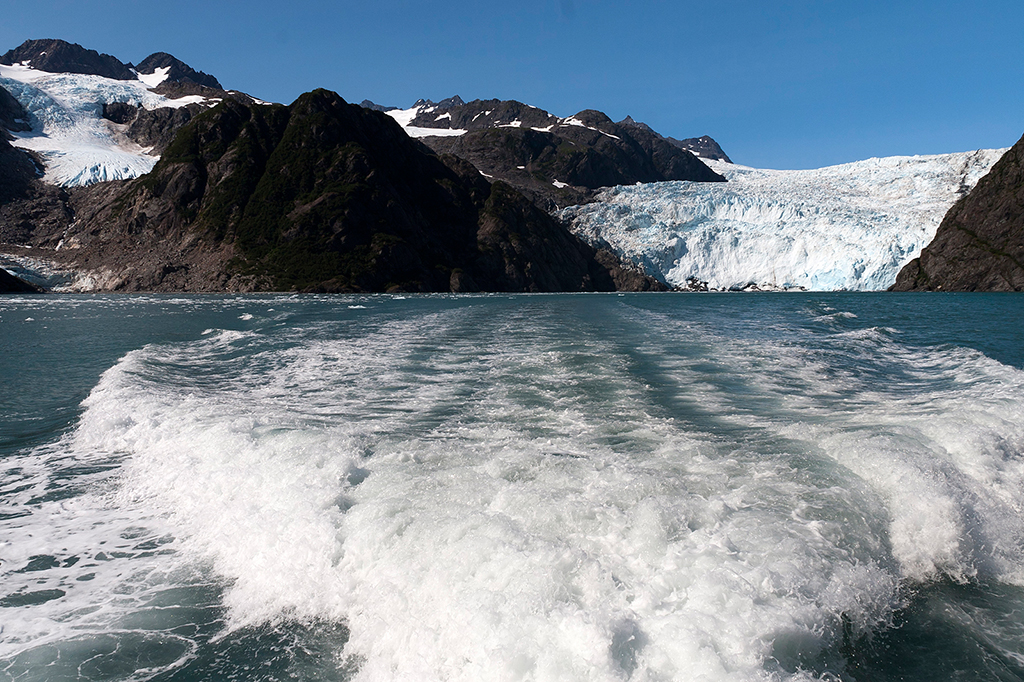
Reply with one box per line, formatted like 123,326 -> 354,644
0,294 -> 1024,681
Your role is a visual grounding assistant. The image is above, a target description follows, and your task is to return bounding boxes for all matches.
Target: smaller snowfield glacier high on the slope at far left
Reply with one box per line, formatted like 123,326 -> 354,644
0,65 -> 214,186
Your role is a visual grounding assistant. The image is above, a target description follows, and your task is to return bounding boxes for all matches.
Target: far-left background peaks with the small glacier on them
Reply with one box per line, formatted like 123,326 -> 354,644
0,40 -> 255,186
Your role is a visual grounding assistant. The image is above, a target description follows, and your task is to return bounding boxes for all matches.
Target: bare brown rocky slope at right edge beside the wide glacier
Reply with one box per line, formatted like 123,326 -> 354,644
892,137 -> 1024,291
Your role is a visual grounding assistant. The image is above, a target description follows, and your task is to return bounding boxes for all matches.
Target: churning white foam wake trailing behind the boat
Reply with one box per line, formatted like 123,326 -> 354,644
12,298 -> 1024,681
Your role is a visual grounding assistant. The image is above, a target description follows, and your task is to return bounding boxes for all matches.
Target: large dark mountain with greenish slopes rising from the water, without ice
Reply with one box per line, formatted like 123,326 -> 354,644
0,90 -> 659,292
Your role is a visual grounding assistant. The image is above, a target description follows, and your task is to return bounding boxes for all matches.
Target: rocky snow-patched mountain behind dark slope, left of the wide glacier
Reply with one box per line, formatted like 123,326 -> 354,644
370,95 -> 725,209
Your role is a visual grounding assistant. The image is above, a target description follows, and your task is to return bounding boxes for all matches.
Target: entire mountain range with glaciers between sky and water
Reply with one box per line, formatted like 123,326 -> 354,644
0,40 -> 1024,292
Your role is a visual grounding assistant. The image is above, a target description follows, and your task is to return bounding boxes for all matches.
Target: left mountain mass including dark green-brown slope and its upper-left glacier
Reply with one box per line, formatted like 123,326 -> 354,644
0,40 -> 664,292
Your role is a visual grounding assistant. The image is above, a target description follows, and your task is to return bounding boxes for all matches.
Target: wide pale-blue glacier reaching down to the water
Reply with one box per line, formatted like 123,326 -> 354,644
559,150 -> 1006,291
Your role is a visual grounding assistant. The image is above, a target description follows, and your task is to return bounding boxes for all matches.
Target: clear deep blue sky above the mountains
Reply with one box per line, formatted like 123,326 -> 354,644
0,0 -> 1024,168
